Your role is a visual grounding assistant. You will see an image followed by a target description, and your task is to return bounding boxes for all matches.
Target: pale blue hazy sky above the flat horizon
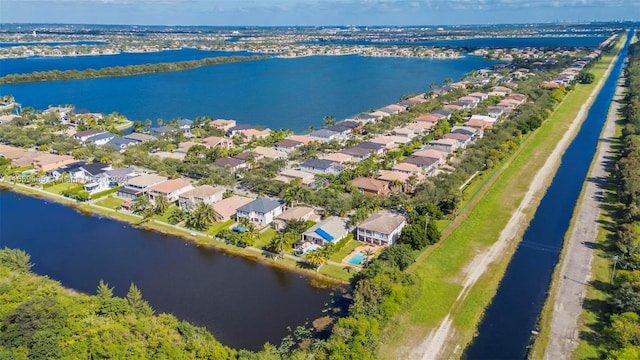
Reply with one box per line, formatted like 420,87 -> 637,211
0,0 -> 640,26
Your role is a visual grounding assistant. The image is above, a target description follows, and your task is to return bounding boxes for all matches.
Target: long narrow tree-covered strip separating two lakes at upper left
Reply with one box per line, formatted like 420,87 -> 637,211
0,55 -> 270,84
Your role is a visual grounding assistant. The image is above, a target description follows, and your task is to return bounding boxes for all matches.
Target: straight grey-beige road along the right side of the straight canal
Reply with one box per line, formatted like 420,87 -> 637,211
544,77 -> 622,360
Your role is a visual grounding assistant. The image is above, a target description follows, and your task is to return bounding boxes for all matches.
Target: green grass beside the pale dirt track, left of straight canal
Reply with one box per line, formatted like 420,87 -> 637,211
381,38 -> 614,359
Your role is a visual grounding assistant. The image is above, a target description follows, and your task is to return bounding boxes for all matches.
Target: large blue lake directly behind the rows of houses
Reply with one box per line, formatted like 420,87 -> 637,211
0,55 -> 497,132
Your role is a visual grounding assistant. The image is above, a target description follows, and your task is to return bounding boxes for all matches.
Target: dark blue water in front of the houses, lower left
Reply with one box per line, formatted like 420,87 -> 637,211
0,190 -> 339,350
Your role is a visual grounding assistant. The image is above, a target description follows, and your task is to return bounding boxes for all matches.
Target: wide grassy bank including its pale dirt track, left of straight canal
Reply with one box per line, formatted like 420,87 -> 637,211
381,32 -> 621,359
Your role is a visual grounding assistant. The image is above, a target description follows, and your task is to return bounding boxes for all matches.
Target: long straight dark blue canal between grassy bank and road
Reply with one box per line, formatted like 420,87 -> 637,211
463,28 -> 632,359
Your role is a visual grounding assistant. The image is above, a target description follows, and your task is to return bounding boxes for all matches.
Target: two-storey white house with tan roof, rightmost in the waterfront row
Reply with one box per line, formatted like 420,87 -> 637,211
356,211 -> 407,246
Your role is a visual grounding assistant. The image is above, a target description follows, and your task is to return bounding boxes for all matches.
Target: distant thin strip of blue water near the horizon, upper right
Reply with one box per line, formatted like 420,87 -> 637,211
303,36 -> 607,48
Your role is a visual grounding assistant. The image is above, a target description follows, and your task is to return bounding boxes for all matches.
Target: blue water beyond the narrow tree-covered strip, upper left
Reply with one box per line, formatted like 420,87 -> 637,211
0,49 -> 252,76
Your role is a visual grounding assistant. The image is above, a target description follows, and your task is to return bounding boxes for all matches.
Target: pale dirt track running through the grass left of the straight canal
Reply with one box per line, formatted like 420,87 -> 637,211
410,52 -> 617,360
